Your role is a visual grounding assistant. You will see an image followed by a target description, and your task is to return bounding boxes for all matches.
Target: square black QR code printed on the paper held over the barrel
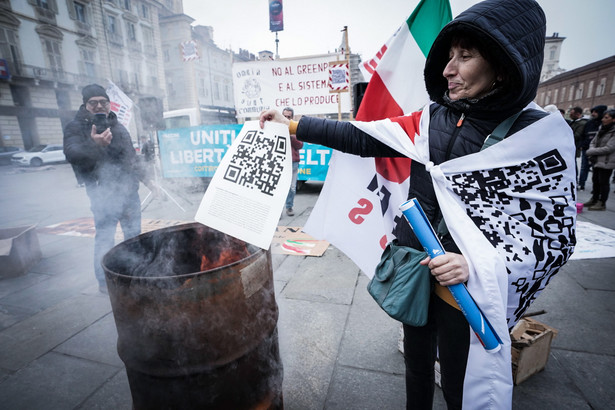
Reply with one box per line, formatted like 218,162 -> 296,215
224,131 -> 287,196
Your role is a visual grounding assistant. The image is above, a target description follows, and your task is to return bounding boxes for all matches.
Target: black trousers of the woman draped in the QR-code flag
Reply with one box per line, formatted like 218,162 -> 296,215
404,294 -> 470,410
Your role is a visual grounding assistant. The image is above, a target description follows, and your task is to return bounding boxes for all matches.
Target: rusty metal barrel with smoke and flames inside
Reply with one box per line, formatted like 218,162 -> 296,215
103,223 -> 283,410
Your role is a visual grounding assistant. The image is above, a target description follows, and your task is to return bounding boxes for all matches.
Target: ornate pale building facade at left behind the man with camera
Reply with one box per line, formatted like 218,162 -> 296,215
0,0 -> 171,149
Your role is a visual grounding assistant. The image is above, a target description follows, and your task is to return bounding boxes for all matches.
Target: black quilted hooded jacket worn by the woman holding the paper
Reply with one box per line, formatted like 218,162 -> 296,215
297,0 -> 548,252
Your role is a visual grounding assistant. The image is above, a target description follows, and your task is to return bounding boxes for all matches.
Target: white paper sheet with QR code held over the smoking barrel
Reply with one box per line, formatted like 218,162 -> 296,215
194,121 -> 292,249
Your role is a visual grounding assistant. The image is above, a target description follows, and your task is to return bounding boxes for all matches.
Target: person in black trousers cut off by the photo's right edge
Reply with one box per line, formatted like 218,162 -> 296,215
583,110 -> 615,211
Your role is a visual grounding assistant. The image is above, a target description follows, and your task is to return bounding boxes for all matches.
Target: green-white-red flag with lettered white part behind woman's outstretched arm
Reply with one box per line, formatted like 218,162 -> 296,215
304,0 -> 451,278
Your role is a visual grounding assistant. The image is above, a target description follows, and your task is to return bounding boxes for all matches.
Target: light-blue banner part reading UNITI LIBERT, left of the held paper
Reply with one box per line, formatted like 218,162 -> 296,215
158,124 -> 243,178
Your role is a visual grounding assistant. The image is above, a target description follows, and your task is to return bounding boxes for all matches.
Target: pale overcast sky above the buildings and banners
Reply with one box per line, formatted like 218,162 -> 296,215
183,0 -> 615,70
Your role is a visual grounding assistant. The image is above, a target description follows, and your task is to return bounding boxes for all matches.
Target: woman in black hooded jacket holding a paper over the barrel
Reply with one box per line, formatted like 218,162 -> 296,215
260,0 -> 574,409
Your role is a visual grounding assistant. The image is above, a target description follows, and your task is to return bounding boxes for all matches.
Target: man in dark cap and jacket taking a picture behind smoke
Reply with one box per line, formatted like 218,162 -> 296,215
64,84 -> 157,293
